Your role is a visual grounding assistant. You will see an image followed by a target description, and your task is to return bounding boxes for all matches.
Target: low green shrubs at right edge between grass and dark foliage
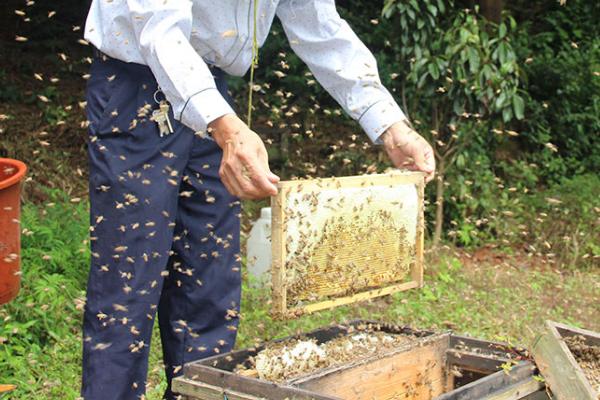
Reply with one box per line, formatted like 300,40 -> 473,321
449,172 -> 600,269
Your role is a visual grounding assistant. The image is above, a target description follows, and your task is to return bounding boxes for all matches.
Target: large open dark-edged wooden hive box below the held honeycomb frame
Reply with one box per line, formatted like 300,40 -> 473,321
173,321 -> 547,400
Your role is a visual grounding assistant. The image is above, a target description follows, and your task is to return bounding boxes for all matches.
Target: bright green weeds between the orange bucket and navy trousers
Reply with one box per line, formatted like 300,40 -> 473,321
0,193 -> 89,398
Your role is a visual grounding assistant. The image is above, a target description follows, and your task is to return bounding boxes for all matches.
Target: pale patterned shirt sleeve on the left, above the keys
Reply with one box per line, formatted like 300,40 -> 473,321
127,0 -> 234,131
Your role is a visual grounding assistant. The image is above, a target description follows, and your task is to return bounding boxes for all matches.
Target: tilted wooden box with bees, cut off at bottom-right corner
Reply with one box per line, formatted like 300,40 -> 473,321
532,321 -> 600,400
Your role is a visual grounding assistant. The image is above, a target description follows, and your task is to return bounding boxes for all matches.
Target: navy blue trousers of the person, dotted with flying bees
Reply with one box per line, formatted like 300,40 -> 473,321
82,57 -> 240,400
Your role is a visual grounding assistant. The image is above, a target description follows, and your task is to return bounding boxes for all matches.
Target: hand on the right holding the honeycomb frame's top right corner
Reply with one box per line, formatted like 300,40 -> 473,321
381,121 -> 435,182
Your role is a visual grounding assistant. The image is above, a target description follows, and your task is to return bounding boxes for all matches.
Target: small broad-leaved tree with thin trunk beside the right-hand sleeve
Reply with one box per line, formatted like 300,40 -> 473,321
384,0 -> 525,245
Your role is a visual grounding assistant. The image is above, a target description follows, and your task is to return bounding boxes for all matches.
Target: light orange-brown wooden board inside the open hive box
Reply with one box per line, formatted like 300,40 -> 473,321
298,335 -> 449,400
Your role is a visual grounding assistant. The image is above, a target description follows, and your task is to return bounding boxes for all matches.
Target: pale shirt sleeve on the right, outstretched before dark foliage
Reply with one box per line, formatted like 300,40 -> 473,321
277,0 -> 406,143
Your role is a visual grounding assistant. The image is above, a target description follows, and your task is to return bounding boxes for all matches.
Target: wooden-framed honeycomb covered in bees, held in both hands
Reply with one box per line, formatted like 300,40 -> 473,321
271,172 -> 424,318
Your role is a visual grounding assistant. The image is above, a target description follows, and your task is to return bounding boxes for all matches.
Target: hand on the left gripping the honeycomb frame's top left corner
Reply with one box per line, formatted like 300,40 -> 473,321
209,114 -> 279,200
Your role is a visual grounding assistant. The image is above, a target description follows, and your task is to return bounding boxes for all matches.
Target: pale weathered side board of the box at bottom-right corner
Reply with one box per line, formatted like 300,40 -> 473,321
531,321 -> 598,400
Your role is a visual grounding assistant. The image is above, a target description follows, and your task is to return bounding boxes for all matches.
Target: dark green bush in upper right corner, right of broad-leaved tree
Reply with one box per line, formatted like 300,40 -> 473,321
514,0 -> 600,182
